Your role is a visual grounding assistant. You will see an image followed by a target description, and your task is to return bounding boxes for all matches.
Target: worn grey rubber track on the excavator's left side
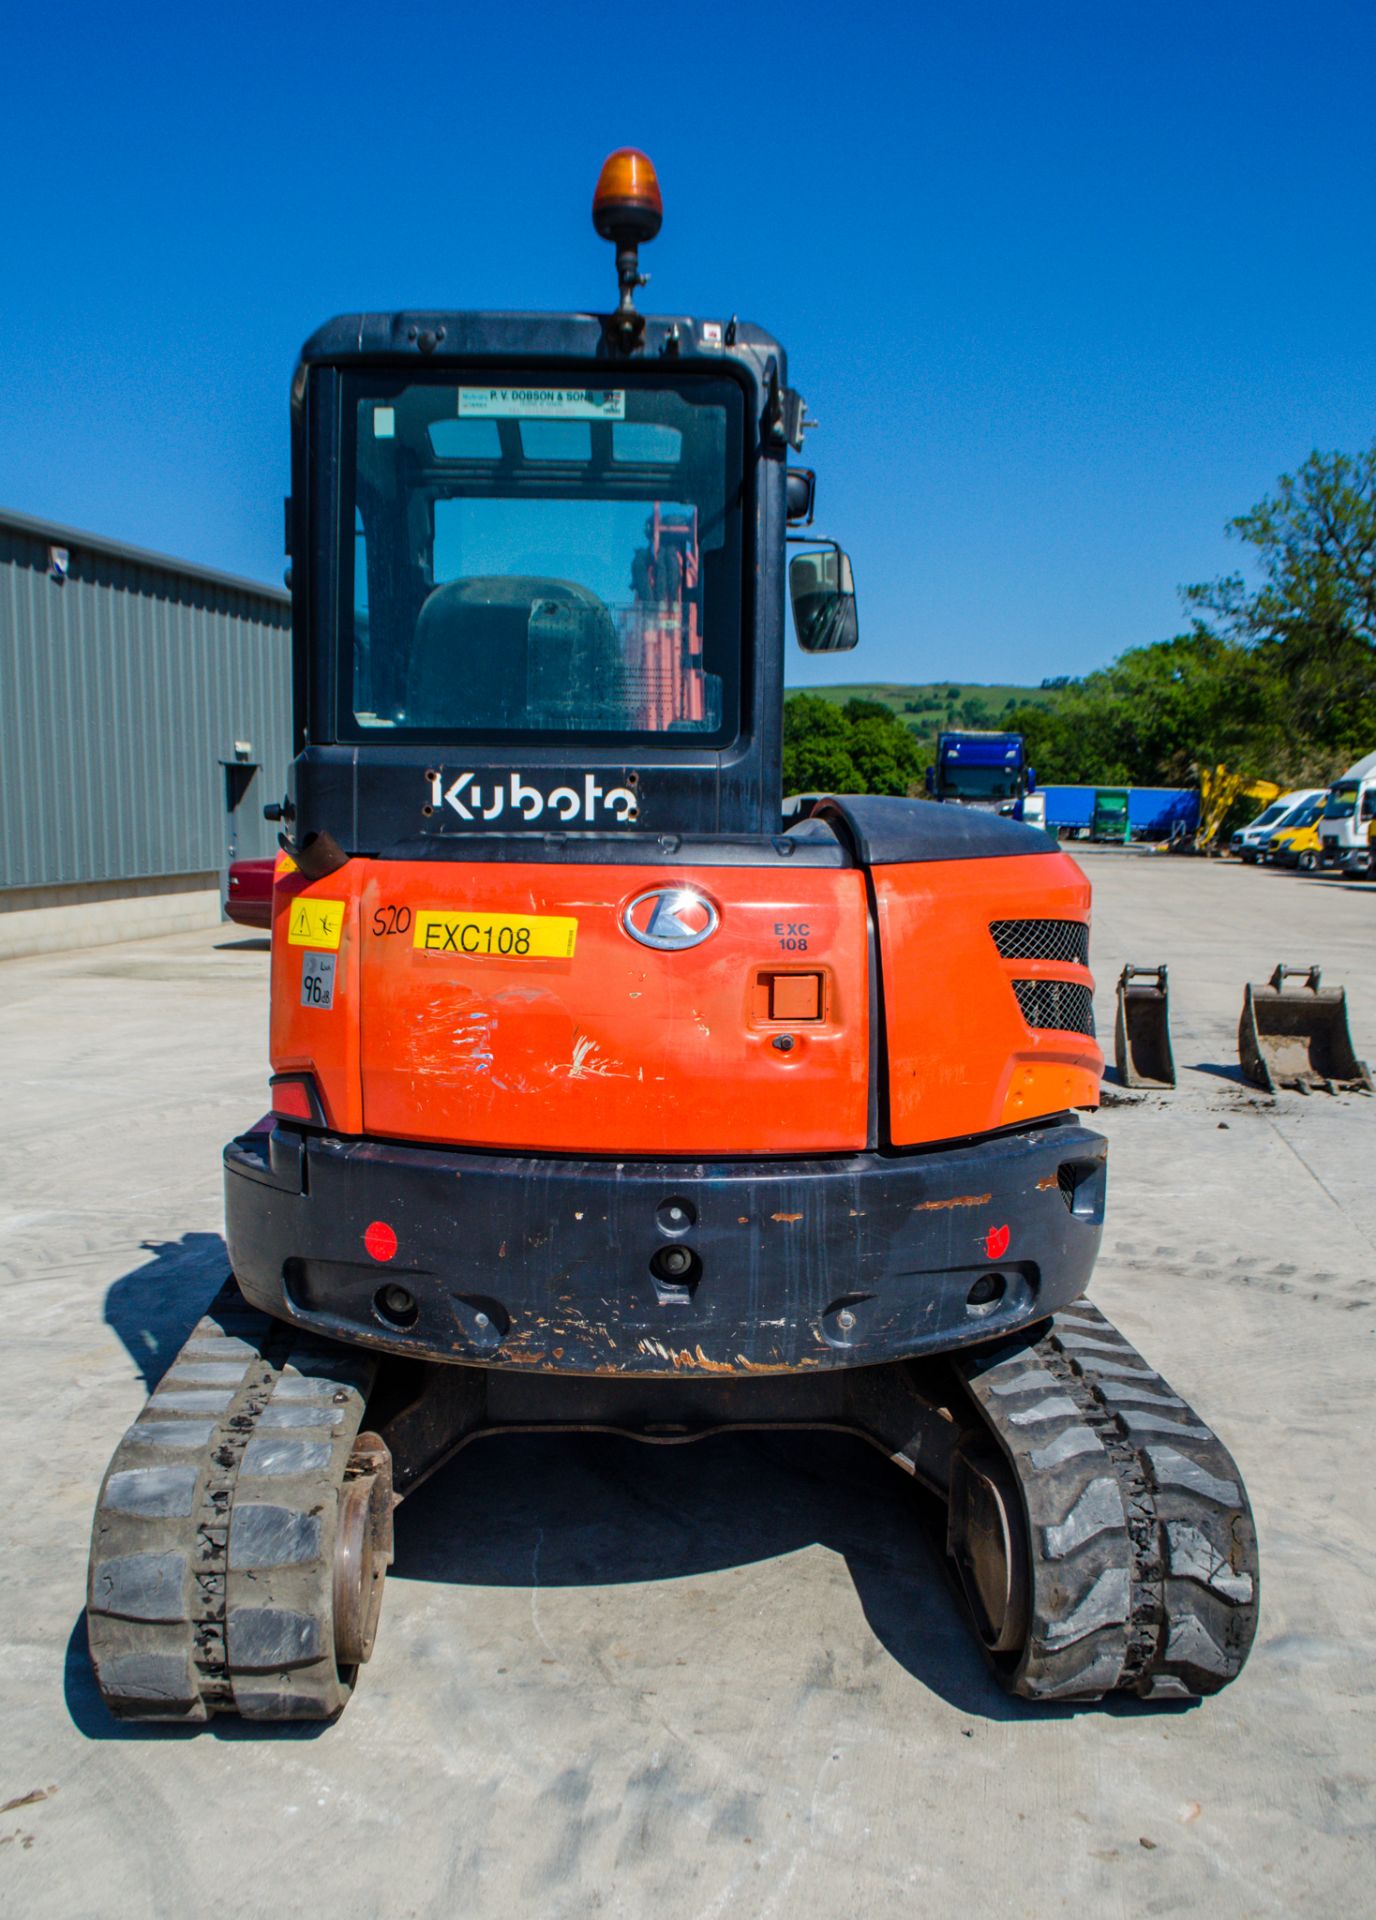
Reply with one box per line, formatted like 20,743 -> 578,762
86,1281 -> 376,1722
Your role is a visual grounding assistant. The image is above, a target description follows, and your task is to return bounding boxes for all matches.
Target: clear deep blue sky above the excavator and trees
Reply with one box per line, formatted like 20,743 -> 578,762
0,0 -> 1376,682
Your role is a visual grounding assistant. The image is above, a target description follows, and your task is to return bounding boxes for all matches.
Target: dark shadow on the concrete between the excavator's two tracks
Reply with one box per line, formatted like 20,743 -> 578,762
384,1430 -> 1151,1720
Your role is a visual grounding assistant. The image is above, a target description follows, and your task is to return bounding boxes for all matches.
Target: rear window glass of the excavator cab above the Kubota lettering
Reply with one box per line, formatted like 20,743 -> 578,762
338,374 -> 745,743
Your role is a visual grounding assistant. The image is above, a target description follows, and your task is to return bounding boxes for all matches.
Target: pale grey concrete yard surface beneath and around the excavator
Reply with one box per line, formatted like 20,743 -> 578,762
0,851 -> 1376,1920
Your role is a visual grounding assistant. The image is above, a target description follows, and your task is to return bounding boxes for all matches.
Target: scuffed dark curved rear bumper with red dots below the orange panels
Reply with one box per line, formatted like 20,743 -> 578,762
225,1121 -> 1105,1377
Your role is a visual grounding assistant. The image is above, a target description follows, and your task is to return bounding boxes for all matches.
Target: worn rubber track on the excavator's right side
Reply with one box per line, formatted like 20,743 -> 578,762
958,1300 -> 1259,1699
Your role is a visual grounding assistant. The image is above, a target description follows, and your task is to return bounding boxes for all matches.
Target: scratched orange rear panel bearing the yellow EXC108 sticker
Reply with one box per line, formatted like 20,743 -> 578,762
273,860 -> 869,1158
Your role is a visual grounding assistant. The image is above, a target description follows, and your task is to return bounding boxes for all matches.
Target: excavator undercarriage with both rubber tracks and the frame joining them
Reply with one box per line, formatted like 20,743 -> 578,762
88,1283 -> 1257,1722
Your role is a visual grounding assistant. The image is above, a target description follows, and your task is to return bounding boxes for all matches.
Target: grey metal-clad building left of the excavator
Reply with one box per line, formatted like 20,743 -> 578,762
0,511 -> 292,912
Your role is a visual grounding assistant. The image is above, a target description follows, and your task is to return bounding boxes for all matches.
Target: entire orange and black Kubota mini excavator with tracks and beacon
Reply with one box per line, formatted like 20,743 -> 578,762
88,150 -> 1255,1722
